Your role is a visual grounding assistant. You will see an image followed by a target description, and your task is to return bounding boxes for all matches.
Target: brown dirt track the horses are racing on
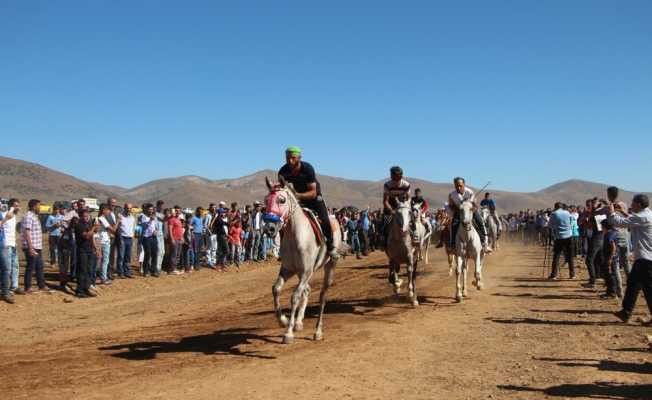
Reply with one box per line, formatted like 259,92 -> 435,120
0,242 -> 652,400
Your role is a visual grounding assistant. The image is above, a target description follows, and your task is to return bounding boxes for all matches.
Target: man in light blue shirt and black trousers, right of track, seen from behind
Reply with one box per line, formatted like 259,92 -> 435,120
548,202 -> 575,279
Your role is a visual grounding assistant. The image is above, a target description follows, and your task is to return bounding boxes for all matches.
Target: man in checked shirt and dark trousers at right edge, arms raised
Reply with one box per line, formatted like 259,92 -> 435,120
609,194 -> 652,322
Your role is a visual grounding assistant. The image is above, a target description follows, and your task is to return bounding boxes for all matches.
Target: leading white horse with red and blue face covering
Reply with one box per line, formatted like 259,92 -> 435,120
265,178 -> 342,344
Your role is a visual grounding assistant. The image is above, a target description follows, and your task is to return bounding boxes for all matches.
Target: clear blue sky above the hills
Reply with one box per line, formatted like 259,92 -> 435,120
0,0 -> 652,191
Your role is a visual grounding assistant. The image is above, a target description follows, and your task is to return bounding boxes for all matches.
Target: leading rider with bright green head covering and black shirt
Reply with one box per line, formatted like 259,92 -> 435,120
278,146 -> 339,259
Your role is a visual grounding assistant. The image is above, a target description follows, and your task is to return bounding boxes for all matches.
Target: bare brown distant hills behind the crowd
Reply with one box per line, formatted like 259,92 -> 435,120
0,157 -> 648,211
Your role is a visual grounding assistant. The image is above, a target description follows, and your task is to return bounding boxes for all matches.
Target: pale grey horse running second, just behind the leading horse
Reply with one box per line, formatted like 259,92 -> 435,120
385,201 -> 419,307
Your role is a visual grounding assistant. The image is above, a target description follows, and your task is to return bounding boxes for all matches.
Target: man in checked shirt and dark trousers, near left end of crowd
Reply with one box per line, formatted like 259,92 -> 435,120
20,199 -> 50,294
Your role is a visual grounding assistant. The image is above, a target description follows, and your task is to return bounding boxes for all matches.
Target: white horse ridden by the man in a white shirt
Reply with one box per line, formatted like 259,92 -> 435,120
455,200 -> 484,302
